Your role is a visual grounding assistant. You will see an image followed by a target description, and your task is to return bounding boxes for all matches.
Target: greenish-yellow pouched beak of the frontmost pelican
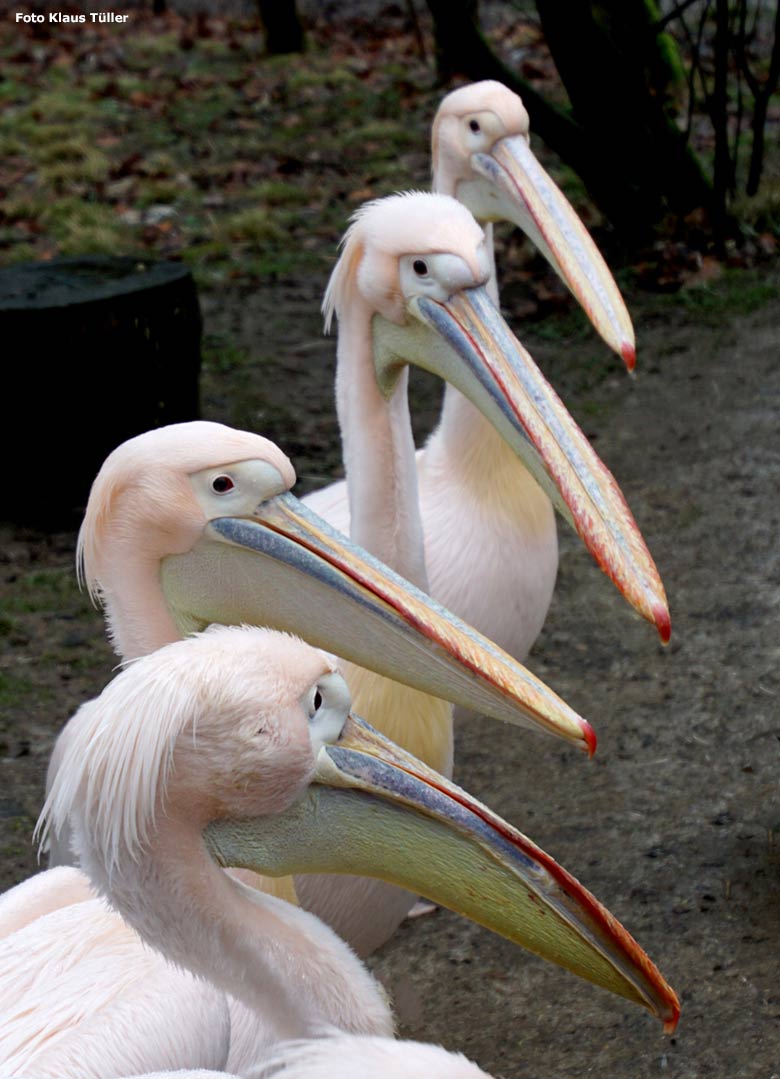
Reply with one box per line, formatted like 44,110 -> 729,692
205,716 -> 680,1033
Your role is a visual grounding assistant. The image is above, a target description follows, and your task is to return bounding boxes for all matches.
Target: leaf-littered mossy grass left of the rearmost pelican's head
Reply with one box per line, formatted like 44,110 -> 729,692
0,12 -> 434,285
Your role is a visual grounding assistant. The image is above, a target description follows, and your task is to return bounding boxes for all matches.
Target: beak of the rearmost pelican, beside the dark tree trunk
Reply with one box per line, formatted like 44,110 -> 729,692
471,135 -> 637,371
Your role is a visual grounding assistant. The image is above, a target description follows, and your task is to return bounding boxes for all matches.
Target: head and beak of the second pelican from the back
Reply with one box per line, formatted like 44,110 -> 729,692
324,193 -> 671,641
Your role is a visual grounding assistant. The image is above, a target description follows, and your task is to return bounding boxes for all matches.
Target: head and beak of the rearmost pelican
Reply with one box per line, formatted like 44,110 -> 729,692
433,81 -> 635,370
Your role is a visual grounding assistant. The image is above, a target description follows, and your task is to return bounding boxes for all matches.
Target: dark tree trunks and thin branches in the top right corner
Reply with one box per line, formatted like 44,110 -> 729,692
428,0 -> 780,248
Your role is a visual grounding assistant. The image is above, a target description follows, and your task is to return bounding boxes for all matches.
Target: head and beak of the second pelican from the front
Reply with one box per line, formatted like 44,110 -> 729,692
78,421 -> 596,752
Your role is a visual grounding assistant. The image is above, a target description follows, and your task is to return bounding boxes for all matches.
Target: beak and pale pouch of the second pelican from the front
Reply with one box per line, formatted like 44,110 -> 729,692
161,493 -> 596,754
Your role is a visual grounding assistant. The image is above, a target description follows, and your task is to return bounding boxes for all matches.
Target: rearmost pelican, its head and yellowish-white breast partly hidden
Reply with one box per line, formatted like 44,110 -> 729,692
419,81 -> 671,659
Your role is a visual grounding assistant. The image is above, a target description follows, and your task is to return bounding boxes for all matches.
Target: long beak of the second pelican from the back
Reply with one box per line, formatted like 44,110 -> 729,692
403,286 -> 671,642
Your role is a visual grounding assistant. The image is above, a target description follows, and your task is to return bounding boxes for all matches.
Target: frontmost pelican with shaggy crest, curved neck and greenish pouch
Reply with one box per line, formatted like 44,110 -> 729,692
22,626 -> 679,1079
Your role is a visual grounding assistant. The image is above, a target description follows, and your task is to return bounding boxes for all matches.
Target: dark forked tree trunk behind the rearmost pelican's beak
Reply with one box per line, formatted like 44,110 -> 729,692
428,0 -> 713,243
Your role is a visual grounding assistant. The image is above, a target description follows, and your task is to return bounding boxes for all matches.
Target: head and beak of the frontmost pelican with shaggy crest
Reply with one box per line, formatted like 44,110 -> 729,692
42,626 -> 679,1027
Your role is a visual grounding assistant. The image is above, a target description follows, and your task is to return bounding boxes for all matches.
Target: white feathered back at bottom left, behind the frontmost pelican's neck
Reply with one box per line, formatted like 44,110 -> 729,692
0,866 -> 231,1079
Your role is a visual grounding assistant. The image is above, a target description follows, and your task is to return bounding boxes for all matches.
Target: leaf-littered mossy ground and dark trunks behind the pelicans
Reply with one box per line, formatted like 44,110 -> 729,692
0,0 -> 780,289
